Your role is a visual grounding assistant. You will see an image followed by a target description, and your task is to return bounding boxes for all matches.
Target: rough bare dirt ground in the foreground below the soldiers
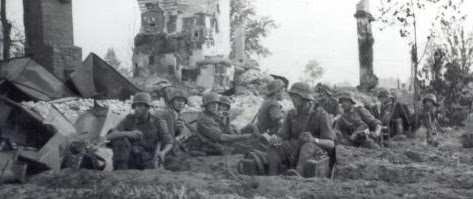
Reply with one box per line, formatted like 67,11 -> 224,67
0,131 -> 473,198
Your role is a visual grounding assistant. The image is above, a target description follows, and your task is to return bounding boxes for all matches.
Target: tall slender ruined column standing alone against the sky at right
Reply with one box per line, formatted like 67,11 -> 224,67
355,0 -> 378,91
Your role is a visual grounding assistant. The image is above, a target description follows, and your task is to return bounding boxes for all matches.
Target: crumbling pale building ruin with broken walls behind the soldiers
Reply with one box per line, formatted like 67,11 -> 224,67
133,0 -> 235,89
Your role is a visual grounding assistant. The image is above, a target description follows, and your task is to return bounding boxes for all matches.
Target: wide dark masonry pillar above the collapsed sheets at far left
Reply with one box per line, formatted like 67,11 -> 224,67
23,0 -> 82,81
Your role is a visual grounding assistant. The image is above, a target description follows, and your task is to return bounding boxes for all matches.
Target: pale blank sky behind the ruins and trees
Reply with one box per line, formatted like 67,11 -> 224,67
7,0 -> 473,85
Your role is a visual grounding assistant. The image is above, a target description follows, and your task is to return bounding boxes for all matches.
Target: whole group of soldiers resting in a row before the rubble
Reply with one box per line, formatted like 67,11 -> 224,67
107,79 -> 438,175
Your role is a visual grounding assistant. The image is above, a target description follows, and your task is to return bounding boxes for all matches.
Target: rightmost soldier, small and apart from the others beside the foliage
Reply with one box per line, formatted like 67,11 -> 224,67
420,94 -> 440,147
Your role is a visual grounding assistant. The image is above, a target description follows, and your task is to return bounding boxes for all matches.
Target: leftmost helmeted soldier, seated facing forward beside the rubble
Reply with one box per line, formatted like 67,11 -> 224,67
107,92 -> 173,170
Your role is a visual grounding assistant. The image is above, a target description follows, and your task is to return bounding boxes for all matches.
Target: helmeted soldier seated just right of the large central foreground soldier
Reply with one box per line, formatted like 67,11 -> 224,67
336,92 -> 381,148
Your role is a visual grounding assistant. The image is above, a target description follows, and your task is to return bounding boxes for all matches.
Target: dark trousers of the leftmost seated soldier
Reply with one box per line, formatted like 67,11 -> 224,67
112,138 -> 156,170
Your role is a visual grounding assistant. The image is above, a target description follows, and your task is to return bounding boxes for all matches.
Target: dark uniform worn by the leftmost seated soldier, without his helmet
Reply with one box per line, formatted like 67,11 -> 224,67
110,114 -> 173,170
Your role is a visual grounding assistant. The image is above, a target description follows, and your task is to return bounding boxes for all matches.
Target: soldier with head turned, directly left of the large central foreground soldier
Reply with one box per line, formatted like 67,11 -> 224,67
256,79 -> 286,135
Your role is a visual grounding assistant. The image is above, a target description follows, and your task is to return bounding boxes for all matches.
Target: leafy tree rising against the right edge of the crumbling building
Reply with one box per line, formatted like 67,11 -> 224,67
230,0 -> 277,59
